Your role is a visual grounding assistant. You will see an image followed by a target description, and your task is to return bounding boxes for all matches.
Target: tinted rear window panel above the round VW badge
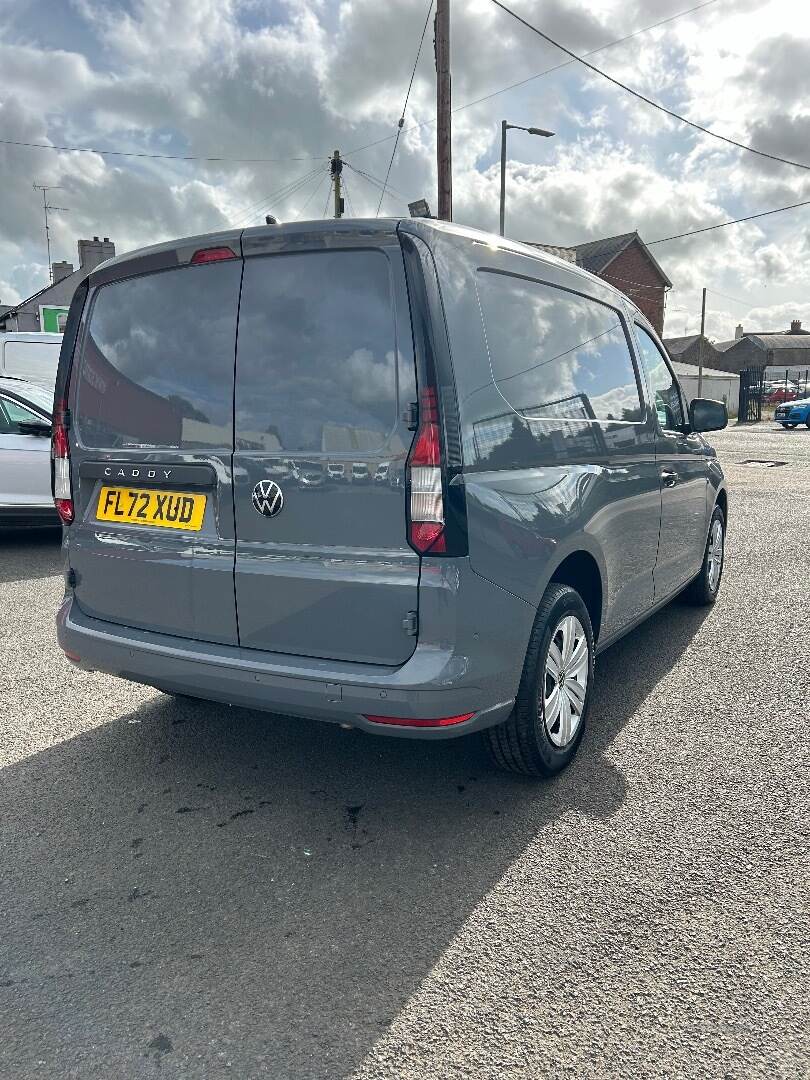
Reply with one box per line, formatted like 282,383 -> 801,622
237,251 -> 403,454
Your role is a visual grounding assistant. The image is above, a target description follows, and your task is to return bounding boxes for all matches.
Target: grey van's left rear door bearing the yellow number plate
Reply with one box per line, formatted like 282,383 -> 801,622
69,257 -> 242,644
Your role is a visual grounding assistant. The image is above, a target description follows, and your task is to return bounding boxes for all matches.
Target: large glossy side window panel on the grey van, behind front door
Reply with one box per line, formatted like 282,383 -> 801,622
478,271 -> 643,422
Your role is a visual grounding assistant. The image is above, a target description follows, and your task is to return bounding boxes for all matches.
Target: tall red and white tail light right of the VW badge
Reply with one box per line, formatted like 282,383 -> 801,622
408,387 -> 447,555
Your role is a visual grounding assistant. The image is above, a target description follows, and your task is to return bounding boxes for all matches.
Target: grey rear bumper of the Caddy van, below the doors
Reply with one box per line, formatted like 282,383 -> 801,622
56,592 -> 516,739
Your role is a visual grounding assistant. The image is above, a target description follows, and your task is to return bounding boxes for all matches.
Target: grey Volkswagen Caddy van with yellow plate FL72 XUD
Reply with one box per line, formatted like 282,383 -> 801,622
52,219 -> 728,775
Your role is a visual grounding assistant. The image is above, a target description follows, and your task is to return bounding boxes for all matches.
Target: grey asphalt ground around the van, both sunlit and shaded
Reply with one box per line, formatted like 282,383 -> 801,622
0,424 -> 810,1080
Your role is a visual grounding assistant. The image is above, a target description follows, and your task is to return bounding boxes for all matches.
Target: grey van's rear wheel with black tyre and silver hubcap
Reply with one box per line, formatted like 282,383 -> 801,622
483,582 -> 594,778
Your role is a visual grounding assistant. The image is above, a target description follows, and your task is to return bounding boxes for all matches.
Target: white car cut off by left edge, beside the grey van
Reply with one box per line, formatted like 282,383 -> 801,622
0,376 -> 59,527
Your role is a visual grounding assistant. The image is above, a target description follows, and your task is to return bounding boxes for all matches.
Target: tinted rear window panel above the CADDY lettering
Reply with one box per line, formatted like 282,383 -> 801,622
78,259 -> 242,449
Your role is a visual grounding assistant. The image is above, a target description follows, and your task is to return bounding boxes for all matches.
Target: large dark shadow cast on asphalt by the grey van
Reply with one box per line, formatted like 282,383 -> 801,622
0,606 -> 704,1080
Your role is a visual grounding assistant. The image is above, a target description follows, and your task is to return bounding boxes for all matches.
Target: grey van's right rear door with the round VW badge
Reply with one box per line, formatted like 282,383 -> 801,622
233,230 -> 419,665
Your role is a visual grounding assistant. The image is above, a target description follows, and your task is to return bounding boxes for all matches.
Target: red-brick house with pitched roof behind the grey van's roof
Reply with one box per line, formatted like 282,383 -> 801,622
529,232 -> 672,335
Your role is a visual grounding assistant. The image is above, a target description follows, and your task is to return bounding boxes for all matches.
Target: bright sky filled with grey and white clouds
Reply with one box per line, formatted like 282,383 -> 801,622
0,0 -> 810,340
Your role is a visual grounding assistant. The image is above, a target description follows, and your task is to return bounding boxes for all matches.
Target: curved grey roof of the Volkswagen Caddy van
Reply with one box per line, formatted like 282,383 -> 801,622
90,217 -> 635,307
